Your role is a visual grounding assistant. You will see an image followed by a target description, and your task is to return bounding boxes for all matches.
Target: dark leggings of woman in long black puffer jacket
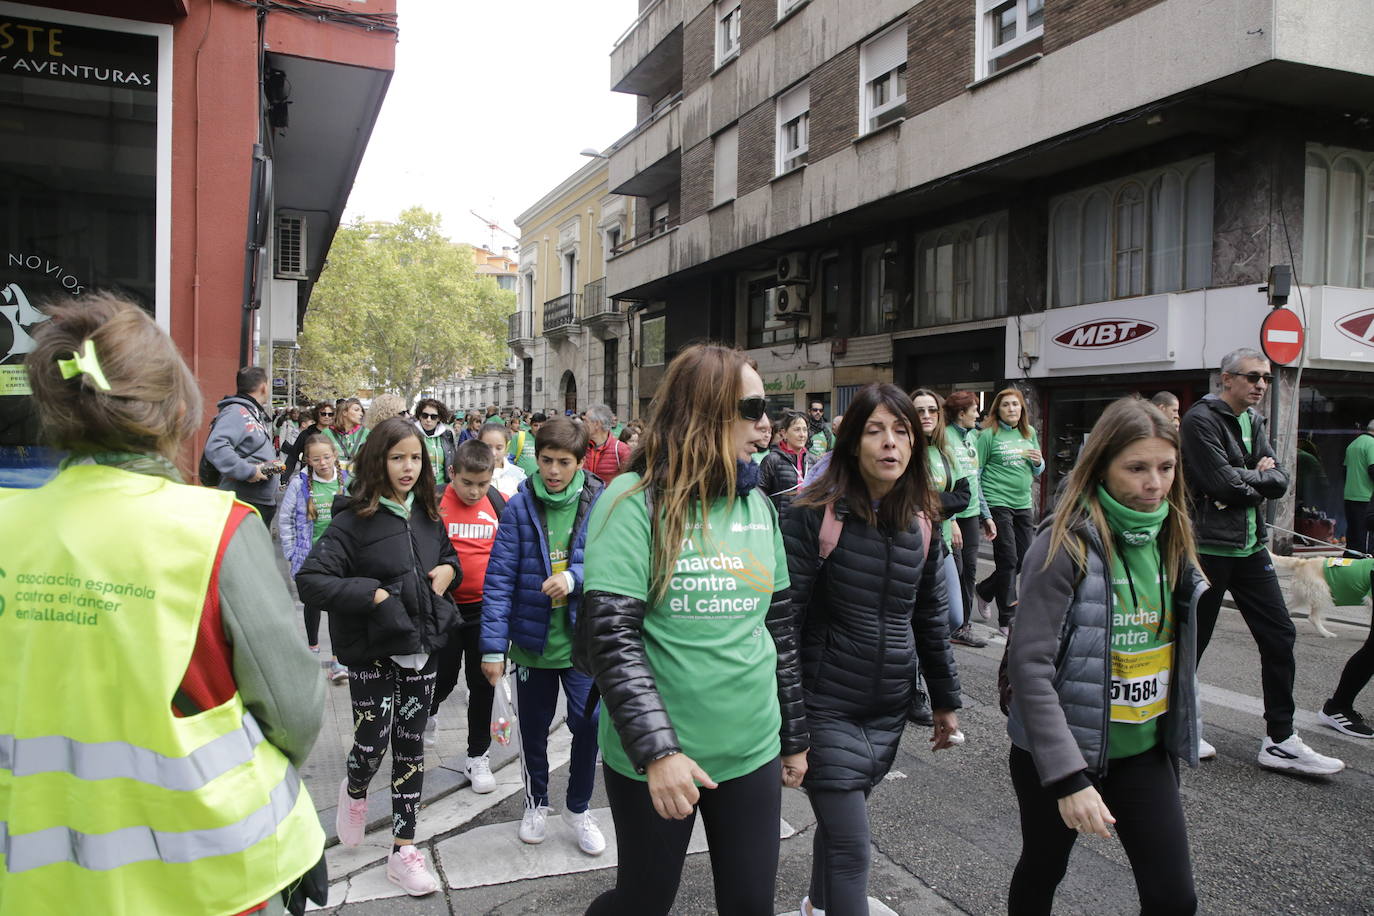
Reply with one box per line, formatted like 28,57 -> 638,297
807,788 -> 871,916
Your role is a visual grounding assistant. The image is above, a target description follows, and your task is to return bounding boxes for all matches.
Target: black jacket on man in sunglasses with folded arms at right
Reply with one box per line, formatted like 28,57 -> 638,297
1179,394 -> 1289,548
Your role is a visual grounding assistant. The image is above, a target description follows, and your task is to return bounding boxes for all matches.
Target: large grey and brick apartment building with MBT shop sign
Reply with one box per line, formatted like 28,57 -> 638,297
607,0 -> 1374,538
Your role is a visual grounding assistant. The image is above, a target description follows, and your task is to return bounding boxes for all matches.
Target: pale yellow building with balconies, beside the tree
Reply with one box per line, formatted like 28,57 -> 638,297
508,158 -> 635,417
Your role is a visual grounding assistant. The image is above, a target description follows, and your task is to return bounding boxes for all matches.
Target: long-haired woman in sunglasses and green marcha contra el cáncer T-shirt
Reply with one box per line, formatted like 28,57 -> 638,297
577,345 -> 807,916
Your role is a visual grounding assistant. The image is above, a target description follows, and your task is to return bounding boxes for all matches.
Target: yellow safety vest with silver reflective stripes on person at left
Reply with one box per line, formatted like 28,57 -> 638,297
0,464 -> 324,916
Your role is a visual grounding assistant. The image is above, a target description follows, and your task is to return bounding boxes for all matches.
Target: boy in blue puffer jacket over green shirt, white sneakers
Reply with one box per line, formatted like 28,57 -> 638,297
481,417 -> 606,856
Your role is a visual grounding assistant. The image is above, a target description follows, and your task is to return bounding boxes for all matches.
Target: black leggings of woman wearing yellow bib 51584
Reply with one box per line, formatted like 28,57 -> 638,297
1007,746 -> 1198,916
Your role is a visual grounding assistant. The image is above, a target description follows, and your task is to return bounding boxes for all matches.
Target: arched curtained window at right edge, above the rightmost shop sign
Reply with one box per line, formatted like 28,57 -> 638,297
1301,144 -> 1374,288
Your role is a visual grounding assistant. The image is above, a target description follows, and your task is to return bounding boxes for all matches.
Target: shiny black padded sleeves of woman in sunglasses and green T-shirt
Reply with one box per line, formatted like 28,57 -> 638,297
577,486 -> 809,773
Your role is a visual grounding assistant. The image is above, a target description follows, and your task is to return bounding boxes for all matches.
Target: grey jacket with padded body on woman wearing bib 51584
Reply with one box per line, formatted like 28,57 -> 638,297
1007,518 -> 1206,798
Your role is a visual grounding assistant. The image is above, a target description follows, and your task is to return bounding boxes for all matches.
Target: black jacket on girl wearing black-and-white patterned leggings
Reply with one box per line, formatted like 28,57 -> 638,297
295,496 -> 463,665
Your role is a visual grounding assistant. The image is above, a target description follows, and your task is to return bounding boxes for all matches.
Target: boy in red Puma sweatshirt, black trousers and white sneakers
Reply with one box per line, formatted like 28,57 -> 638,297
425,439 -> 506,794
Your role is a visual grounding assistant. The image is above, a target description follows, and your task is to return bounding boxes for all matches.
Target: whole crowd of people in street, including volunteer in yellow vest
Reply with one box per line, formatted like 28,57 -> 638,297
0,297 -> 1374,916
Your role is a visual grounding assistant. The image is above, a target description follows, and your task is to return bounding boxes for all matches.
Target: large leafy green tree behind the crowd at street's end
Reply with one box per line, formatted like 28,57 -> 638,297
301,207 -> 515,402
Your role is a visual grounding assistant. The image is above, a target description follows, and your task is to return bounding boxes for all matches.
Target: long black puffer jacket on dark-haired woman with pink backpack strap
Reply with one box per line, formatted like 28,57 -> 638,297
782,501 -> 962,790
